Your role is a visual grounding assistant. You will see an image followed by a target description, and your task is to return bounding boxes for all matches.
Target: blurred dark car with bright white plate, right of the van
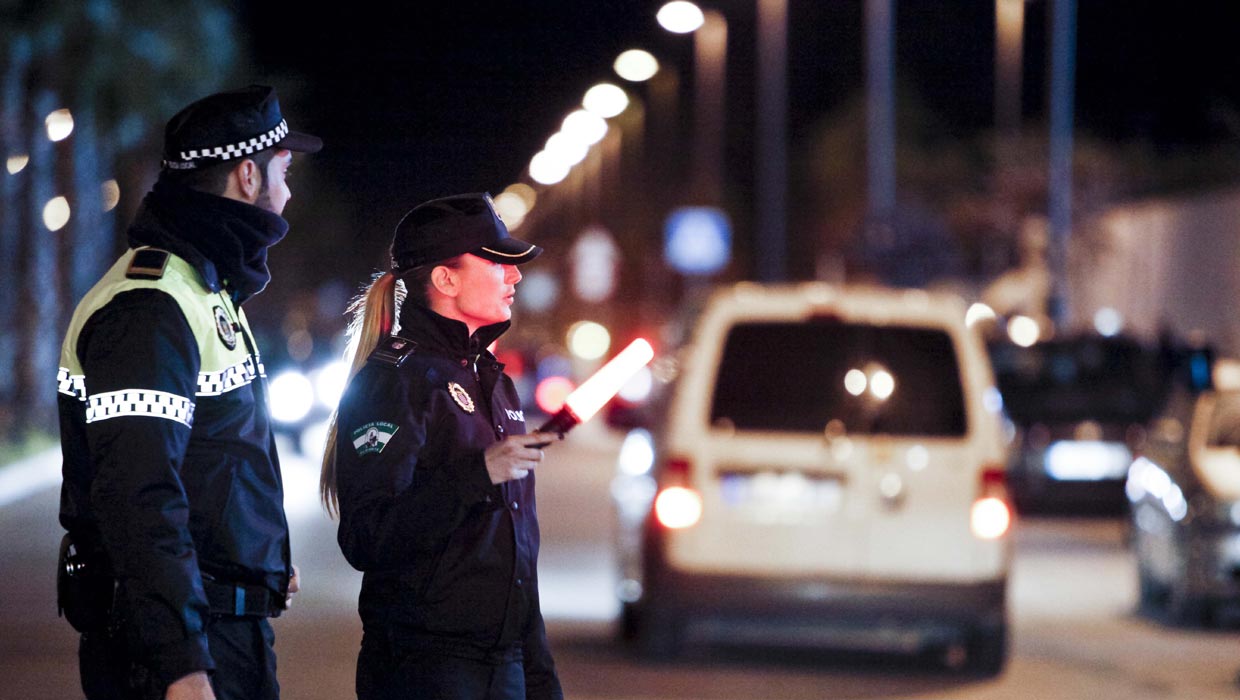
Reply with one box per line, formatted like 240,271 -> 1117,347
990,333 -> 1169,515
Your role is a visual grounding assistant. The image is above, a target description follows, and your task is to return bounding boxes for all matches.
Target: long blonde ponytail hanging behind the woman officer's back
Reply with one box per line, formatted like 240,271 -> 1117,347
319,273 -> 405,518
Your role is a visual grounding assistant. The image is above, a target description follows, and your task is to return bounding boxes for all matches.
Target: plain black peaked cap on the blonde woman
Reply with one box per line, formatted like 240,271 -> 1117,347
392,193 -> 542,274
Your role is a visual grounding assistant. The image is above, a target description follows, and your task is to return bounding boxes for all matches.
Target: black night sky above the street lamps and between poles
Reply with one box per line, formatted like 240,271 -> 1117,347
230,0 -> 1240,292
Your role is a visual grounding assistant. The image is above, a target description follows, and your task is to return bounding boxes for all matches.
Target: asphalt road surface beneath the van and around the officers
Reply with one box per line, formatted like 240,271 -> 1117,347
0,425 -> 1240,700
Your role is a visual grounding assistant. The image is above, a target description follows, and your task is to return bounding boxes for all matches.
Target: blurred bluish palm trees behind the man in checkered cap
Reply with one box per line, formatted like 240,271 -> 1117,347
0,0 -> 239,437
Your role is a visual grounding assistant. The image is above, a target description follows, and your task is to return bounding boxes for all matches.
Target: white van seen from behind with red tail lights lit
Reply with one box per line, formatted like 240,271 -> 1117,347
613,284 -> 1012,675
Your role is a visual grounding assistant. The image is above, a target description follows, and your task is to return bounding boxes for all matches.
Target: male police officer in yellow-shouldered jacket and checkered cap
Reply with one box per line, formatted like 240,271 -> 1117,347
58,85 -> 322,700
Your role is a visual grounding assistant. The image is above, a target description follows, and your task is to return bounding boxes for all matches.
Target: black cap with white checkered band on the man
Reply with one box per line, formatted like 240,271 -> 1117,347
164,85 -> 322,170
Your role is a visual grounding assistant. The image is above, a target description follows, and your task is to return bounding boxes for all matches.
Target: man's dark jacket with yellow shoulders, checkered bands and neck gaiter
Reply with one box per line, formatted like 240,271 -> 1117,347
58,183 -> 291,683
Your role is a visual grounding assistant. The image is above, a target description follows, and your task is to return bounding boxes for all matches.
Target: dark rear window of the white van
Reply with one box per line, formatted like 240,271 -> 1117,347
711,318 -> 966,436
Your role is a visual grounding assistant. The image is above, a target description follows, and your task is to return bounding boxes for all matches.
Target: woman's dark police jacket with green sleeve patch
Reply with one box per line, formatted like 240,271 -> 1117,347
336,305 -> 560,698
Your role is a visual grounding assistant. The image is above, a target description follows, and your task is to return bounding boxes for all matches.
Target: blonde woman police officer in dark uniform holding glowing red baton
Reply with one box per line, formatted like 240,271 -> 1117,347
320,195 -> 563,700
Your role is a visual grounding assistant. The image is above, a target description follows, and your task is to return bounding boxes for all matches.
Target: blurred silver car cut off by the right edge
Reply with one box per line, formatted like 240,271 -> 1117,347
1127,351 -> 1240,626
